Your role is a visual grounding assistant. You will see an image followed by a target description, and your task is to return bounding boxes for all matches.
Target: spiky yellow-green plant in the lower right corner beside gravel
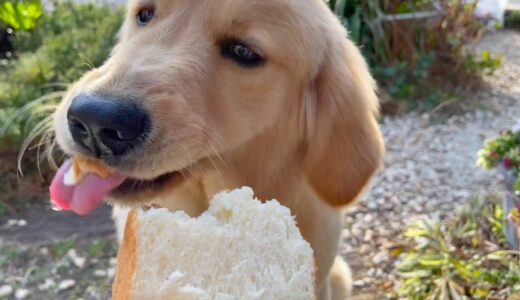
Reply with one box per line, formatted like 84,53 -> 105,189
396,197 -> 520,300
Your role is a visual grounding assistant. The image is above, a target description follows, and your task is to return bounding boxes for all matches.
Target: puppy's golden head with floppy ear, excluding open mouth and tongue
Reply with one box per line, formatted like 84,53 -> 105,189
55,0 -> 383,209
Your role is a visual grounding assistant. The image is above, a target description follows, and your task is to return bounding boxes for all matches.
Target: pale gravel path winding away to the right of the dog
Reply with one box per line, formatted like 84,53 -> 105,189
343,31 -> 520,299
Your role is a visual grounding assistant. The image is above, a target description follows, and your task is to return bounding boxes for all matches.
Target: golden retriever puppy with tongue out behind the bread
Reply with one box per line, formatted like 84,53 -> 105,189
54,0 -> 384,300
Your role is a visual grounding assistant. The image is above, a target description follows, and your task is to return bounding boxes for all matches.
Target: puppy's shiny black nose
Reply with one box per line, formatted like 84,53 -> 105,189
67,94 -> 149,157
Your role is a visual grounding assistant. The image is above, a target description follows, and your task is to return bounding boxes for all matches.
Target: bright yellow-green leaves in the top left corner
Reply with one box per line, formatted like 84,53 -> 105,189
0,0 -> 43,30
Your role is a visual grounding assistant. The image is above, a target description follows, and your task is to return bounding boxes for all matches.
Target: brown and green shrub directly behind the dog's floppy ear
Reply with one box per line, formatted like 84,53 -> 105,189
328,0 -> 501,107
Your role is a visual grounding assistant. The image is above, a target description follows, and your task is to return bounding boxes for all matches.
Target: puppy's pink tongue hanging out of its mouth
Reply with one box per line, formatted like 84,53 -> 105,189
49,160 -> 126,215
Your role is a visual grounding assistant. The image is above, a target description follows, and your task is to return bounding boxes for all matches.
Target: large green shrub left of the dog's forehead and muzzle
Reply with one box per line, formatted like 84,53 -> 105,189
0,2 -> 123,147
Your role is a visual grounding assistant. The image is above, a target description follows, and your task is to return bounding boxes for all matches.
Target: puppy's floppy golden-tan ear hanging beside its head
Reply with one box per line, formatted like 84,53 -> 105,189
303,29 -> 384,206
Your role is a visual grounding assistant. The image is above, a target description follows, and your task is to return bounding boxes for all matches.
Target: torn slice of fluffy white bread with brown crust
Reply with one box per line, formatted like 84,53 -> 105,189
112,187 -> 315,300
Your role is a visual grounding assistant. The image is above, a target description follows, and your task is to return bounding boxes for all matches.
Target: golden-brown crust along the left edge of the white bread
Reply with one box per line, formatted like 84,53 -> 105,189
112,209 -> 137,300
